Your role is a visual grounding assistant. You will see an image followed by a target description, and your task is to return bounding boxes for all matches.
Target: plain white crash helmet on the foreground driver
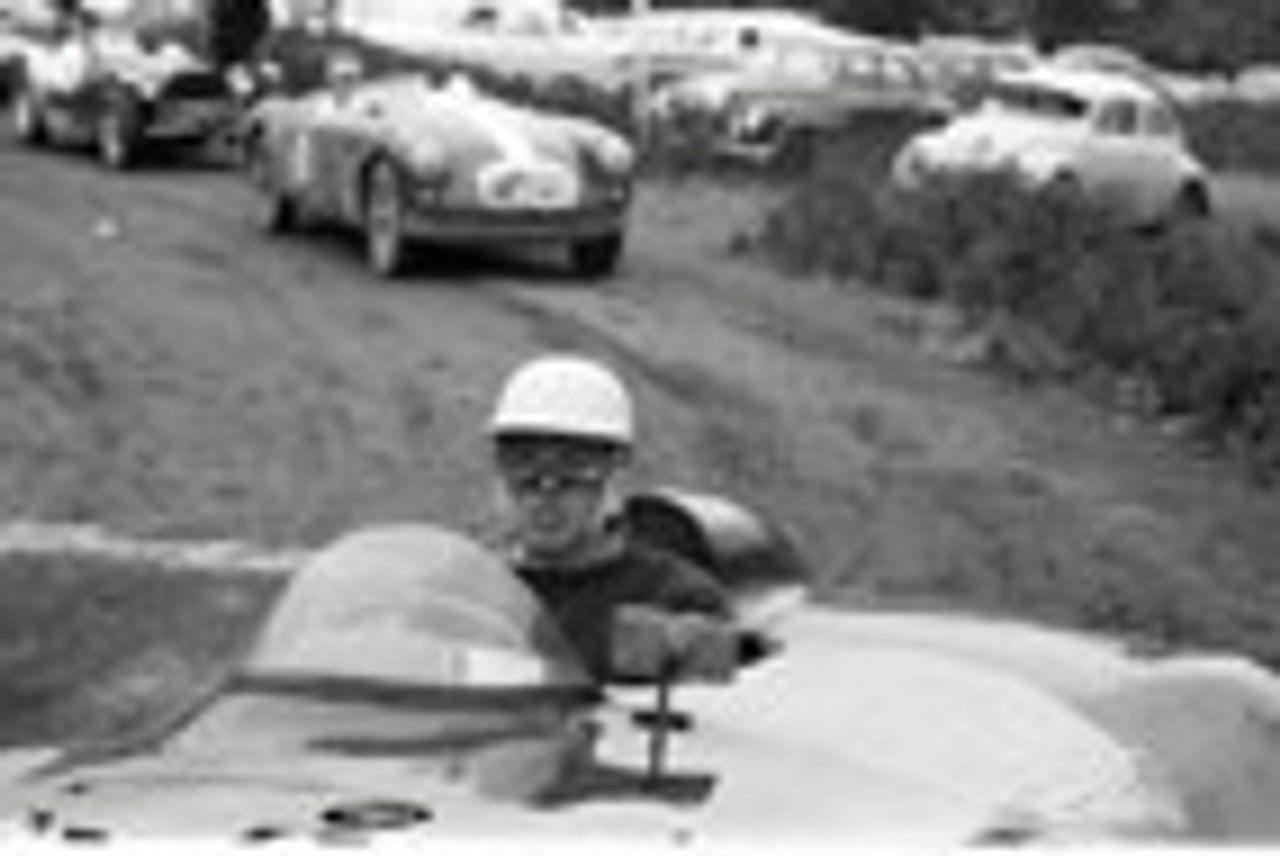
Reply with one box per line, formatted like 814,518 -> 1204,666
489,354 -> 635,447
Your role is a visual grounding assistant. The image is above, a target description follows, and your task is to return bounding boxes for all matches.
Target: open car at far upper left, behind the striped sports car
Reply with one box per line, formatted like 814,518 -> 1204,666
10,11 -> 236,169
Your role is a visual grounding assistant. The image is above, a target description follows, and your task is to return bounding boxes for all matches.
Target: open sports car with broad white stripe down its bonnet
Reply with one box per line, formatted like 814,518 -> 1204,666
246,74 -> 635,278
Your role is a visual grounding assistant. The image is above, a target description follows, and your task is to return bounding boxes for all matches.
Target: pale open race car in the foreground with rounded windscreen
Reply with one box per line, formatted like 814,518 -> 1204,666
0,490 -> 1280,846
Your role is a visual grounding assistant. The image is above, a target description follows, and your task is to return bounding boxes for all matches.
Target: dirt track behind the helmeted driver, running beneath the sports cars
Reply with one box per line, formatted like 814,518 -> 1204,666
0,138 -> 1280,647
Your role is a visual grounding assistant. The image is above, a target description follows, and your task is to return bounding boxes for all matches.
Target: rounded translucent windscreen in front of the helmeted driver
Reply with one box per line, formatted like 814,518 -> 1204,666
246,525 -> 585,697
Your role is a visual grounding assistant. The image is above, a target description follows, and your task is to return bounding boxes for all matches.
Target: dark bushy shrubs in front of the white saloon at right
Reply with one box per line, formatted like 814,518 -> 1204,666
754,152 -> 1280,480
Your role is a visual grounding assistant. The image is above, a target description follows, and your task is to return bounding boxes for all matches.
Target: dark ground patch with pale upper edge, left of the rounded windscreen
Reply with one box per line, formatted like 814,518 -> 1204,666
0,523 -> 296,752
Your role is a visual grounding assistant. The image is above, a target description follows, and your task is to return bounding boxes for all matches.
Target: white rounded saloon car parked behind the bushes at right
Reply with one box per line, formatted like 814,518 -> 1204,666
893,65 -> 1212,223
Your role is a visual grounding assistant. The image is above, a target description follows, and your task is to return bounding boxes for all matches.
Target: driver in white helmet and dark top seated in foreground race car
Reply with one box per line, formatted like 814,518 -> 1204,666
489,354 -> 739,682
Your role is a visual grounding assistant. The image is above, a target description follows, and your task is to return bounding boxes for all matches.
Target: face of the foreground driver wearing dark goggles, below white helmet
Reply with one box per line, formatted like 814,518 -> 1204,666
497,438 -> 622,557
